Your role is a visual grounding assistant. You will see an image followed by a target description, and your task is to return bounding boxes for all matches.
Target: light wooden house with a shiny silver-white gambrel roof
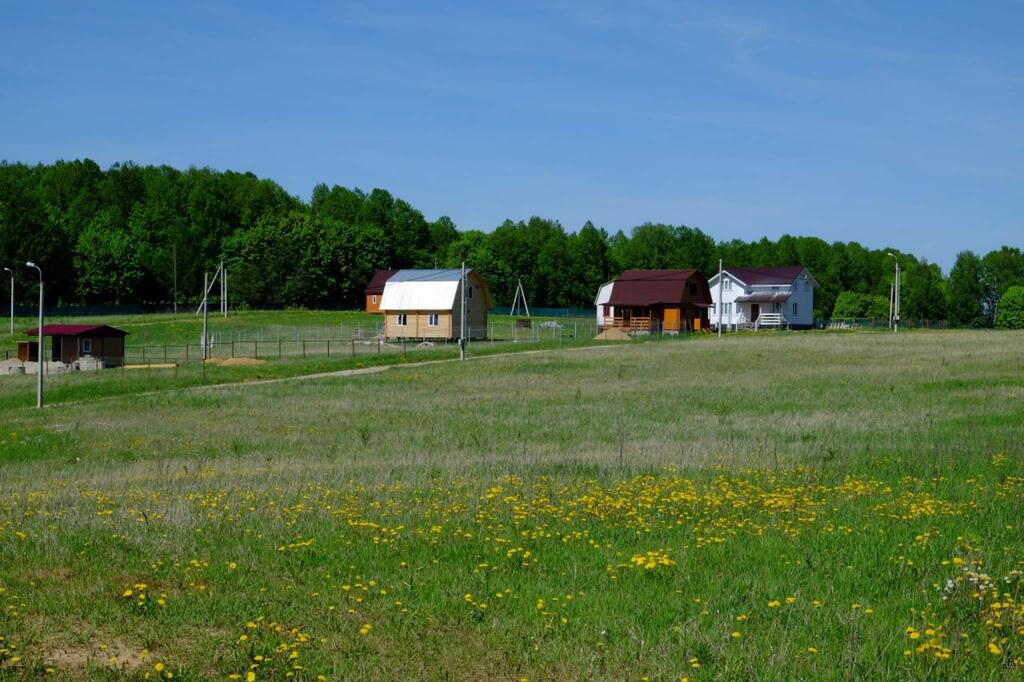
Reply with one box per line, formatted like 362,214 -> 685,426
380,268 -> 490,340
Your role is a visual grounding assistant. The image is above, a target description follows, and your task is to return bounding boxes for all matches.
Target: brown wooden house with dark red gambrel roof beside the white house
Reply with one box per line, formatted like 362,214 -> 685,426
596,269 -> 711,334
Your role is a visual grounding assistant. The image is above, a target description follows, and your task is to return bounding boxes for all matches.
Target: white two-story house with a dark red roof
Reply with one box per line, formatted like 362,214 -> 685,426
708,265 -> 818,329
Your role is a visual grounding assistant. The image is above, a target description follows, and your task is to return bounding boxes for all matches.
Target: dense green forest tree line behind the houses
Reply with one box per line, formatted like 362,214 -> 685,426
0,160 -> 1024,327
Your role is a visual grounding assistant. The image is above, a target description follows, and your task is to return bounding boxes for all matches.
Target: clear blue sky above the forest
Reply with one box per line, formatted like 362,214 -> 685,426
0,0 -> 1024,269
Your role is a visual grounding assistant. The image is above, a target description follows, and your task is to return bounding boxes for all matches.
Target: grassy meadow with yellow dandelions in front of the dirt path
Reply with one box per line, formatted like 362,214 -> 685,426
0,332 -> 1024,680
